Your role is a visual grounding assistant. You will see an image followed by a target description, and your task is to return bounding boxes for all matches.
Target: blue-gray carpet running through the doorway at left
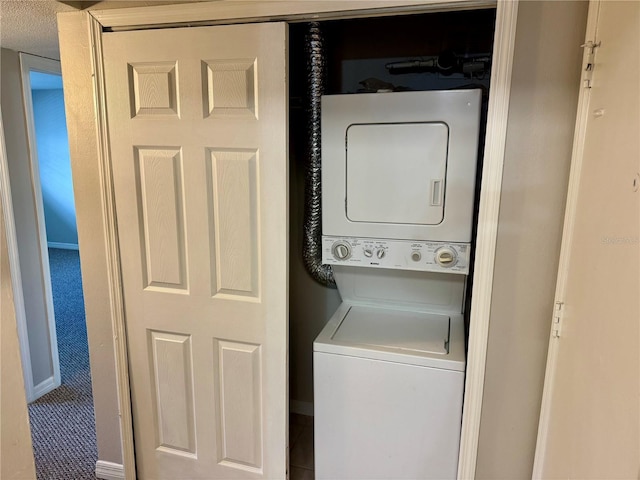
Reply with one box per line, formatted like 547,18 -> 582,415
29,248 -> 97,480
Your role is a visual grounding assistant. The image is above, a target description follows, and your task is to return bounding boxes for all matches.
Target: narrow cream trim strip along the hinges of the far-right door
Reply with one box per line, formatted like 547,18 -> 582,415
531,0 -> 600,479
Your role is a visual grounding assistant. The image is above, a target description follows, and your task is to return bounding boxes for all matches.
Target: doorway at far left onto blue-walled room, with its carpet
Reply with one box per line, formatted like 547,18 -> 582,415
18,54 -> 97,479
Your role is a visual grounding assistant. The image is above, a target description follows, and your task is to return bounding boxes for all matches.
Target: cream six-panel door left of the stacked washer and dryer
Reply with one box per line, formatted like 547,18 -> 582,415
103,23 -> 288,479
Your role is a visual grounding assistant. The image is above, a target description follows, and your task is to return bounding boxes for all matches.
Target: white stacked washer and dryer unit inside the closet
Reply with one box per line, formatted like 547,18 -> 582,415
313,90 -> 481,480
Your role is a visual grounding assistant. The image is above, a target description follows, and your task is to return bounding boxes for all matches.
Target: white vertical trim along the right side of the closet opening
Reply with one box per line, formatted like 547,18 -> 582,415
458,0 -> 518,479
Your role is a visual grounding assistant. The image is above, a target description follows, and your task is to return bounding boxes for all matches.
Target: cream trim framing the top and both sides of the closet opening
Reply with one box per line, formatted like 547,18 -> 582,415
61,0 -> 518,479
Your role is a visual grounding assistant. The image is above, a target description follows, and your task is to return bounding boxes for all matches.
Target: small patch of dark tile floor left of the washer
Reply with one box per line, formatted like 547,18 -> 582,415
289,413 -> 315,480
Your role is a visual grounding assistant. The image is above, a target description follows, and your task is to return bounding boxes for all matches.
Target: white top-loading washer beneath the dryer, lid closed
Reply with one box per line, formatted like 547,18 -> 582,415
313,267 -> 465,480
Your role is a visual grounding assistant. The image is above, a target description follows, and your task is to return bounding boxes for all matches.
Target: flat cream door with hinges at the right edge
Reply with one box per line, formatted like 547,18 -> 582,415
533,1 -> 640,479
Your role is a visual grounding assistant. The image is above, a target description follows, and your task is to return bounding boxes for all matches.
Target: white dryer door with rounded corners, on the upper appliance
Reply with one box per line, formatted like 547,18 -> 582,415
346,122 -> 449,225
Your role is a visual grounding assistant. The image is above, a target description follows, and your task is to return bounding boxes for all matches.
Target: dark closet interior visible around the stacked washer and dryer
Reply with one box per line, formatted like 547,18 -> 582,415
289,9 -> 496,480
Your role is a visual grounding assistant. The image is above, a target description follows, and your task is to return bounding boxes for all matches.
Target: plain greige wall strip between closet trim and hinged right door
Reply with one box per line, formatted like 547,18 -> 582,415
476,1 -> 588,480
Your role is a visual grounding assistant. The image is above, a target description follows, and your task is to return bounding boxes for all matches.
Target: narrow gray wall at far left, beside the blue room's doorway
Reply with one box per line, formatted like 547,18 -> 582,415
0,48 -> 53,385
